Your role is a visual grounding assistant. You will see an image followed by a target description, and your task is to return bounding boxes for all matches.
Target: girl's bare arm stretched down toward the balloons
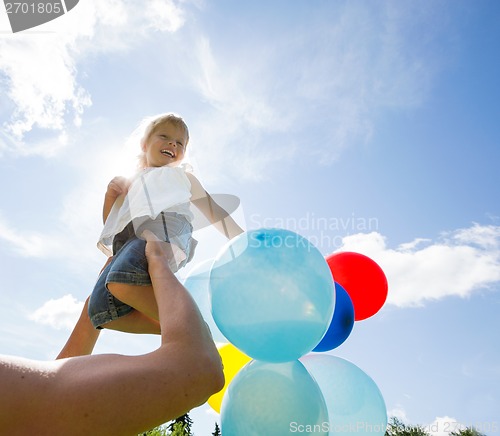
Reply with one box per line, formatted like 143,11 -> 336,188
186,173 -> 243,239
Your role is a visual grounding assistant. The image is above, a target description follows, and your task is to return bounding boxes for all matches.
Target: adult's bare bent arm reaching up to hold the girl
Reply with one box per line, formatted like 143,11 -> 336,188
0,241 -> 224,436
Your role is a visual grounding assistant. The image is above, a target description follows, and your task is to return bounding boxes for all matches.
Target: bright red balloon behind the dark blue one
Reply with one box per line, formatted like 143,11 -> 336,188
326,251 -> 388,321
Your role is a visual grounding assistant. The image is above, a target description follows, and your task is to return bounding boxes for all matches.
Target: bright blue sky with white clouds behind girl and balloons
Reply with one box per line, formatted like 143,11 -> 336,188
0,0 -> 500,435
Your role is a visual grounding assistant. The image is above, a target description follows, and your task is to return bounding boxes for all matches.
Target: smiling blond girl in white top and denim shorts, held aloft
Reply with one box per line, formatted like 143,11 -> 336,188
58,114 -> 243,358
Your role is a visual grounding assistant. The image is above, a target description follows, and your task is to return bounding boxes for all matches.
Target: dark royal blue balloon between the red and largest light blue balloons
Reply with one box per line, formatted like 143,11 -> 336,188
313,283 -> 354,351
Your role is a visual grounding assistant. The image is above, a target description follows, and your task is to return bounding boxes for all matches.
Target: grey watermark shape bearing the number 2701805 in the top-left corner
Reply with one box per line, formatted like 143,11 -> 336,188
3,0 -> 79,33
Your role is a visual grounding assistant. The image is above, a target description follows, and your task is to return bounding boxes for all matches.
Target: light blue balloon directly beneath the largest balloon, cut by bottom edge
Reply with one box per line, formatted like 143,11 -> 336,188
221,360 -> 328,436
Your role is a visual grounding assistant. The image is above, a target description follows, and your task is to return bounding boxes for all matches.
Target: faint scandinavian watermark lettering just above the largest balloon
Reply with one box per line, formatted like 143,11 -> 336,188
247,212 -> 379,251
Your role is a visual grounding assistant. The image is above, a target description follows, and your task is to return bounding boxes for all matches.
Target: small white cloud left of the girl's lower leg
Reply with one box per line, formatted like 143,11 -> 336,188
29,294 -> 83,329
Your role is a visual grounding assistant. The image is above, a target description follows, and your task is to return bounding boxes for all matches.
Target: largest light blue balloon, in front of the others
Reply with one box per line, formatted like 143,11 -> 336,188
210,229 -> 335,362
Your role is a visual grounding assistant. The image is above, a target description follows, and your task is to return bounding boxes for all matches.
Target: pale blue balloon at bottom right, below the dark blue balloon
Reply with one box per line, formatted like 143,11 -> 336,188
301,354 -> 387,436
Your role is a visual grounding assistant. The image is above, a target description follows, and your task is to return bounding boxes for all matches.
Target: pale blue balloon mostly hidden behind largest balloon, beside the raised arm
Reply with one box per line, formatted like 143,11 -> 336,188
183,259 -> 228,343
